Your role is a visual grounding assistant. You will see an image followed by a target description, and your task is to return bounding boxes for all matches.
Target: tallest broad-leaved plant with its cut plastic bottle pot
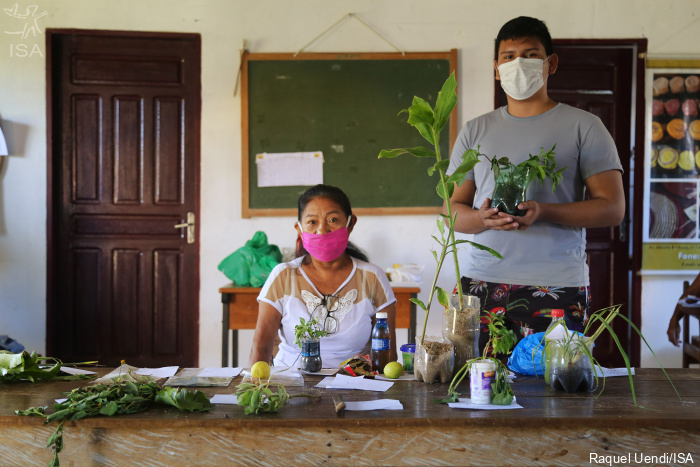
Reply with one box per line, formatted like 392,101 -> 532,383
379,73 -> 502,383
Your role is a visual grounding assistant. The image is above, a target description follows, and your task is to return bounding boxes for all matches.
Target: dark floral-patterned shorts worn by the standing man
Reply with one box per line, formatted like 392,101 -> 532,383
455,277 -> 591,349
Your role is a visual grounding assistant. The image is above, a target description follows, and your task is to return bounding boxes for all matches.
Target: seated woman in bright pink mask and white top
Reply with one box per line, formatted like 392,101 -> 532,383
250,185 -> 396,371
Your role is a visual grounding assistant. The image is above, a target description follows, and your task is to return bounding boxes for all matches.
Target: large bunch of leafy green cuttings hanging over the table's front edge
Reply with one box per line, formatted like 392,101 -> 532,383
15,375 -> 213,467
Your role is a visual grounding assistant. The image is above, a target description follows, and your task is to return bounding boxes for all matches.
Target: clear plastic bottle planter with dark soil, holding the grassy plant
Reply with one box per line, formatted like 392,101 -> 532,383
548,339 -> 596,392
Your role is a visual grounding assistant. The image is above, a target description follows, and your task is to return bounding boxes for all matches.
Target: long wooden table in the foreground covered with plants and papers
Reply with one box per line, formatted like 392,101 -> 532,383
0,369 -> 700,466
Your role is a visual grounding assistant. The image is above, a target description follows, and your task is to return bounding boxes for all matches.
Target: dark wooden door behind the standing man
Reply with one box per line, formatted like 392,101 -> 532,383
496,40 -> 646,367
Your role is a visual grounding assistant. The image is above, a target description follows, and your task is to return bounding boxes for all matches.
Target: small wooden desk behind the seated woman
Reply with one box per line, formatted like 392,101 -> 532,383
219,283 -> 420,367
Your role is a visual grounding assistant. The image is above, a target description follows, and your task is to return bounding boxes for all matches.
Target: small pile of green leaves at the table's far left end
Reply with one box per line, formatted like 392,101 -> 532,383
0,350 -> 94,383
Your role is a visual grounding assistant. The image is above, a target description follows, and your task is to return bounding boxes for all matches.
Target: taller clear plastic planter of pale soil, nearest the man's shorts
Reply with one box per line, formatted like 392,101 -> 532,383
442,294 -> 481,369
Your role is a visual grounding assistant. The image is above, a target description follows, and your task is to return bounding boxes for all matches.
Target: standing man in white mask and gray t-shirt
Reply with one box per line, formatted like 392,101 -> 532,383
448,16 -> 625,352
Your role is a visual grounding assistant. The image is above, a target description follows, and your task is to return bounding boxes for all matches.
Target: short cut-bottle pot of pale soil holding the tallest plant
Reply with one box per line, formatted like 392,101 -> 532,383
413,336 -> 455,384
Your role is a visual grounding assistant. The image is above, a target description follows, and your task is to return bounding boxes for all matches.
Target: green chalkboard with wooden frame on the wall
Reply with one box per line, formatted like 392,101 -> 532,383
241,51 -> 456,217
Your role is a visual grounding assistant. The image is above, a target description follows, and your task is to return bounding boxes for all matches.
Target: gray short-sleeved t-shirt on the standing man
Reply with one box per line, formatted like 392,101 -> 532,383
447,104 -> 622,287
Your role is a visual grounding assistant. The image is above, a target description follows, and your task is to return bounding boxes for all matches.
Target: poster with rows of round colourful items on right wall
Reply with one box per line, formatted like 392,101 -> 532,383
642,60 -> 700,272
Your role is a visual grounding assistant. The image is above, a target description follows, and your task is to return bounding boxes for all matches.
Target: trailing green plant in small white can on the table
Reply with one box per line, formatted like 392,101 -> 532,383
436,312 -> 516,405
